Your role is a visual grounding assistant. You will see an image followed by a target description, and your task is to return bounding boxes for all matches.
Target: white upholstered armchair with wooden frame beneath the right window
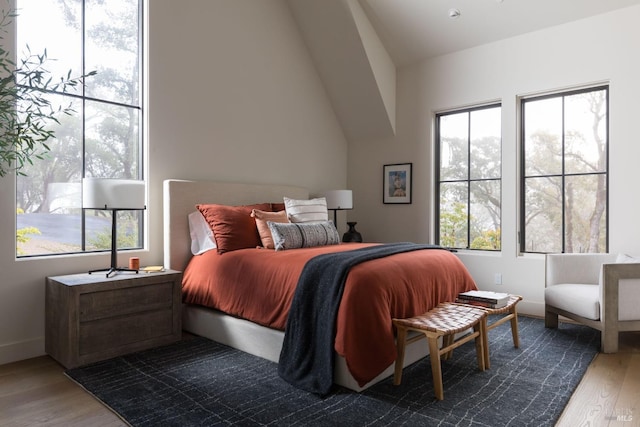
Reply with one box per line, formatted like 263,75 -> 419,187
544,254 -> 640,353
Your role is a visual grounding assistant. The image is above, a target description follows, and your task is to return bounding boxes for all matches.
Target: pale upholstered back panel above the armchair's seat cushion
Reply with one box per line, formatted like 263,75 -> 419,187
545,253 -> 616,286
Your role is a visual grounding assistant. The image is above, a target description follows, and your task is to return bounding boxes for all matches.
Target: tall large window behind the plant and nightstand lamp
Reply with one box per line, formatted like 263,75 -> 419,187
16,0 -> 143,256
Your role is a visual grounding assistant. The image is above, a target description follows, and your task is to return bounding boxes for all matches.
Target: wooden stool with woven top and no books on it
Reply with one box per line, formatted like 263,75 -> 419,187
393,303 -> 488,400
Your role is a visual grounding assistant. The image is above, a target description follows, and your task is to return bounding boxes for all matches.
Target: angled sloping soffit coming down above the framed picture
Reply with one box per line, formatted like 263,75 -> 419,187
289,0 -> 395,141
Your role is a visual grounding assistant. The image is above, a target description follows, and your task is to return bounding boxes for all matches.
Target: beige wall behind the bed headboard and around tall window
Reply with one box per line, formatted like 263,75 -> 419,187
0,0 -> 347,364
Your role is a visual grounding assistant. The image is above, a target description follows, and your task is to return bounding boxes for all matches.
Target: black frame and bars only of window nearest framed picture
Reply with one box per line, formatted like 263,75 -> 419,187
434,101 -> 503,252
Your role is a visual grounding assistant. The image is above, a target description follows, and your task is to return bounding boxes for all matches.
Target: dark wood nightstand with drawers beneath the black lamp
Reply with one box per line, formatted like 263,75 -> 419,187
45,270 -> 182,368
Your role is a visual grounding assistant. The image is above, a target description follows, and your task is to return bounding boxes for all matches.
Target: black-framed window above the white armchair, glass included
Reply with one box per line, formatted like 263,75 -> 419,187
520,86 -> 609,253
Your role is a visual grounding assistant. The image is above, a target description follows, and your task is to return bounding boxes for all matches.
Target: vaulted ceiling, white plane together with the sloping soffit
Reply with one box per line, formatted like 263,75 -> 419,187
287,0 -> 640,141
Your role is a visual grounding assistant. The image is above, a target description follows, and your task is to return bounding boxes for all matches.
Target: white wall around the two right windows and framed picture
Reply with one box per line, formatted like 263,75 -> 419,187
348,6 -> 640,315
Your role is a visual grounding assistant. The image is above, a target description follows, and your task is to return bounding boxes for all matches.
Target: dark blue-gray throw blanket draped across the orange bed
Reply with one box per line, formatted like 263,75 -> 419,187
278,243 -> 442,395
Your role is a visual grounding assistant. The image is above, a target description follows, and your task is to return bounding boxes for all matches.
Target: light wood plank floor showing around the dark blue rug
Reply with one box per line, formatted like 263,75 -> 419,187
0,333 -> 640,427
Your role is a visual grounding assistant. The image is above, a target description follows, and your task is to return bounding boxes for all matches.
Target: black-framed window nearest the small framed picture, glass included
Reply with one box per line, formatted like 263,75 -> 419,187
436,104 -> 502,250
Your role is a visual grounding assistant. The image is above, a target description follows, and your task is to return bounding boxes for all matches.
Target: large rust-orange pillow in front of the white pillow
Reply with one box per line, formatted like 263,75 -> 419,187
196,203 -> 271,254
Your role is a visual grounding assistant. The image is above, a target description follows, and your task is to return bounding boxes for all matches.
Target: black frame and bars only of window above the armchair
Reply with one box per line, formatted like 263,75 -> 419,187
518,83 -> 610,254
